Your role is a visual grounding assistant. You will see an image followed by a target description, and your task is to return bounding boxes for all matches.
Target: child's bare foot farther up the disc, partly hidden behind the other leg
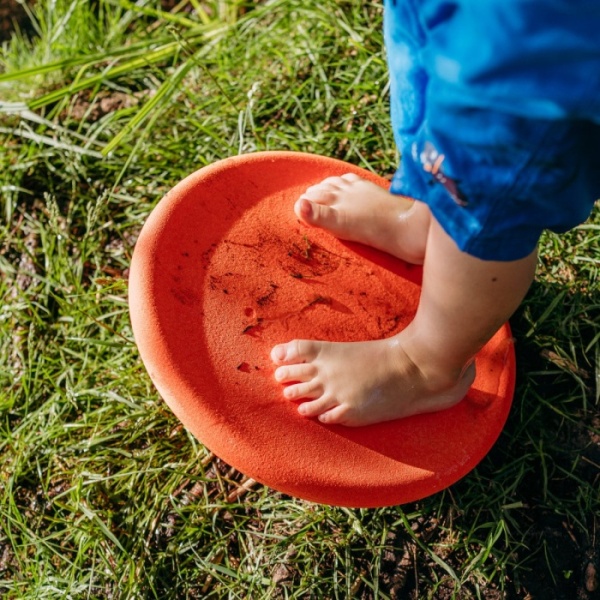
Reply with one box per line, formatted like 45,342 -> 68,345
294,173 -> 430,264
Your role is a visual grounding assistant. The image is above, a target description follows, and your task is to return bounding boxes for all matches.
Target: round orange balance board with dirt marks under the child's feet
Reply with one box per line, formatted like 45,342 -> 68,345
129,152 -> 515,507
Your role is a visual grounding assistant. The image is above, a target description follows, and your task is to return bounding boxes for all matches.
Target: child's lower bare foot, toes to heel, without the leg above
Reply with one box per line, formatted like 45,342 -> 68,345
271,332 -> 475,426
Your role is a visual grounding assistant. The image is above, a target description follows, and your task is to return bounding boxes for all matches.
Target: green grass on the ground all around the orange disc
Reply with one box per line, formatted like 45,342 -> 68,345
0,0 -> 600,600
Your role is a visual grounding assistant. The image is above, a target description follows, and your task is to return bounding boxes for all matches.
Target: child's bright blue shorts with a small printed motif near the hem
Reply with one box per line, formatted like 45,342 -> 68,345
385,0 -> 600,261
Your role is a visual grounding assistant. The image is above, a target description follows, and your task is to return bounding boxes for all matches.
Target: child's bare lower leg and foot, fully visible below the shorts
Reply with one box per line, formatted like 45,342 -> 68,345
271,211 -> 536,426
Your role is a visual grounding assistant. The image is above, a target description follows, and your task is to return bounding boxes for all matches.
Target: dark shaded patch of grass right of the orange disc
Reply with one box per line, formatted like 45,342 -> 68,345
472,282 -> 600,600
